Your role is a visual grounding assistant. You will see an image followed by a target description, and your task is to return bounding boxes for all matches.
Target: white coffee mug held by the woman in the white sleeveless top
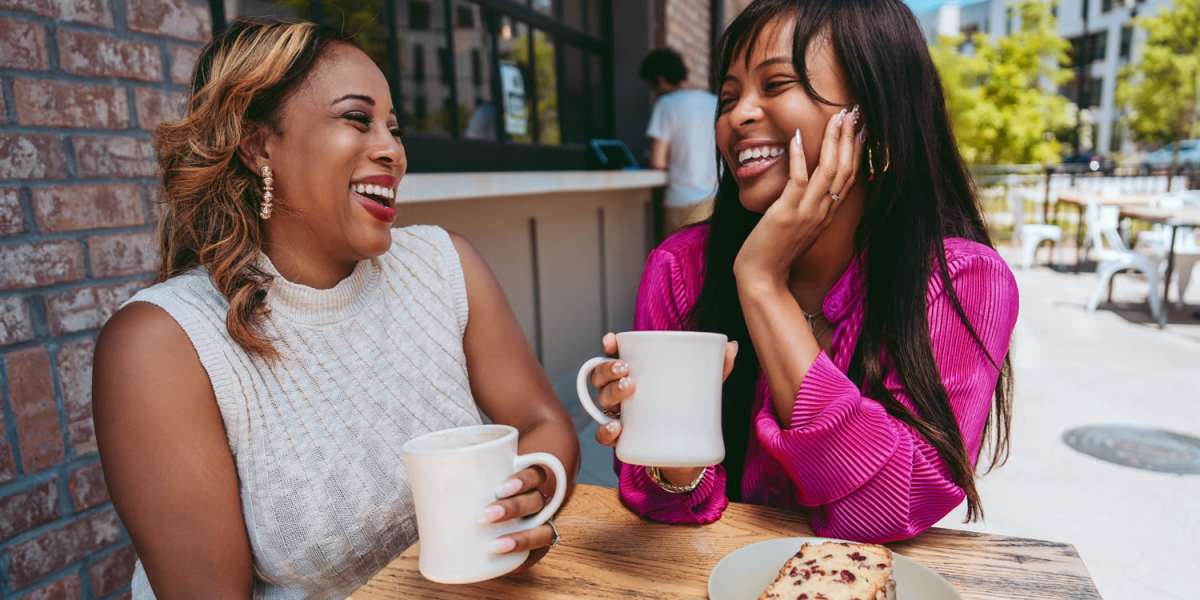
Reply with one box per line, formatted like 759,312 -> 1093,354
403,425 -> 566,583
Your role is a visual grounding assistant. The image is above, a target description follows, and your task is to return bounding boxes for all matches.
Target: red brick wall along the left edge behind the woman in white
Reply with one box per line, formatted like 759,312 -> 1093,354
0,0 -> 211,599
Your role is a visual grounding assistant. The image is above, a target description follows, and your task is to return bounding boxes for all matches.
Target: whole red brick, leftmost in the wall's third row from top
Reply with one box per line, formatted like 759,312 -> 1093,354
12,79 -> 130,130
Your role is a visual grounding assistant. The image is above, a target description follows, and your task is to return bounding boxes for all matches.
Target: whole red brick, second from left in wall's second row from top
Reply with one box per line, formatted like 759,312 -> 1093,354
59,29 -> 162,82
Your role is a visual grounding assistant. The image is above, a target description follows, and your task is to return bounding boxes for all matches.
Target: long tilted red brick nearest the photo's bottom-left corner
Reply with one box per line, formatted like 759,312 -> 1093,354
7,510 -> 121,588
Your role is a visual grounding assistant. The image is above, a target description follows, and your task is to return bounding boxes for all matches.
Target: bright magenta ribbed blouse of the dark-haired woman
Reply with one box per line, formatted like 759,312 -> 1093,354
616,226 -> 1018,542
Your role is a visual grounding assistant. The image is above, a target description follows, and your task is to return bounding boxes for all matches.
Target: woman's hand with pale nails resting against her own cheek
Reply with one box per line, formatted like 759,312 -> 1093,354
733,106 -> 864,283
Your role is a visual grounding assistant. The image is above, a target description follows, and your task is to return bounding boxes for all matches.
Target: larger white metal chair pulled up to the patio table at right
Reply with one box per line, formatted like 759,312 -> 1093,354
1086,202 -> 1163,322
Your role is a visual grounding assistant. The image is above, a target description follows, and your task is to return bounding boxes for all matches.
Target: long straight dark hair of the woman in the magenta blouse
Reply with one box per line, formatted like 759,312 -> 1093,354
690,0 -> 1012,521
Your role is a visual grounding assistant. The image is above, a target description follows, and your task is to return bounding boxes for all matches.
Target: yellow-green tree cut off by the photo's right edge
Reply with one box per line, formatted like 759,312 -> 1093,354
1117,0 -> 1200,163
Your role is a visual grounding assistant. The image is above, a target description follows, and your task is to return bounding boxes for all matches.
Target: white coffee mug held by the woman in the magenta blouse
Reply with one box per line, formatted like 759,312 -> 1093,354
576,331 -> 727,467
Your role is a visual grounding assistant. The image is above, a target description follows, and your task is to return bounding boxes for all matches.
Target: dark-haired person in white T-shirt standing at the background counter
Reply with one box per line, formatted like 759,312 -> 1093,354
638,48 -> 716,235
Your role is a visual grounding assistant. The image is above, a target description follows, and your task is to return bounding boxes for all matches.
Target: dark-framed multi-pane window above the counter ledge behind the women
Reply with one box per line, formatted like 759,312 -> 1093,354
210,0 -> 614,173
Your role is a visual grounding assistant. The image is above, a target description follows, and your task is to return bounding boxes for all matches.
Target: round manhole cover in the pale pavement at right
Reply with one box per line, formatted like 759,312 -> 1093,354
1062,425 -> 1200,475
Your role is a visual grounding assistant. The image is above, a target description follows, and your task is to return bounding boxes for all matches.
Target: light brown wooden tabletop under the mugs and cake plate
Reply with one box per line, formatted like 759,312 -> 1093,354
352,485 -> 1100,600
